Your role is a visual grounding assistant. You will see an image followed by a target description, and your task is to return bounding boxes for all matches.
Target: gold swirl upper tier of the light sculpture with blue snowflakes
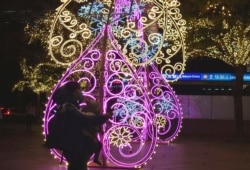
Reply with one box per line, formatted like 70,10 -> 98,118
49,0 -> 186,81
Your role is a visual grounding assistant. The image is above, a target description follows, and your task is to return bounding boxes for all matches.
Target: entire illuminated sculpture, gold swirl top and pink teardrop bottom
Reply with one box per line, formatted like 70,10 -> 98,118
43,0 -> 185,167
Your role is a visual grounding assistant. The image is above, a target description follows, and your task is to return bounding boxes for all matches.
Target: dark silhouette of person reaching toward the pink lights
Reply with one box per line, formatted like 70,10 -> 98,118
52,81 -> 112,170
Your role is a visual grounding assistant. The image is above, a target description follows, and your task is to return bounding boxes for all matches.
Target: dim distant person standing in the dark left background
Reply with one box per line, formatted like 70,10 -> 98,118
26,102 -> 36,132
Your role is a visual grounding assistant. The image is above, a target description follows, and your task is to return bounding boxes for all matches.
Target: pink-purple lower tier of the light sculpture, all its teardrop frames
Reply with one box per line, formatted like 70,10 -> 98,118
44,27 -> 181,167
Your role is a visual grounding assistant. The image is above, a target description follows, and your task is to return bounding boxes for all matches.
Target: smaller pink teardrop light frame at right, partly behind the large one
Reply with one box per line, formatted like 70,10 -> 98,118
137,64 -> 182,142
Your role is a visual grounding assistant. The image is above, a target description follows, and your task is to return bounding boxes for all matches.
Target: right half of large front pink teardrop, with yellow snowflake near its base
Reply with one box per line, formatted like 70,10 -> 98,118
103,28 -> 157,167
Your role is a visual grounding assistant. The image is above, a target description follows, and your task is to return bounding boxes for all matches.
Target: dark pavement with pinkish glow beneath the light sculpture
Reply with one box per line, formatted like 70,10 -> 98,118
0,124 -> 250,170
